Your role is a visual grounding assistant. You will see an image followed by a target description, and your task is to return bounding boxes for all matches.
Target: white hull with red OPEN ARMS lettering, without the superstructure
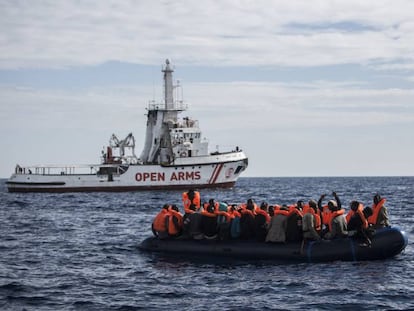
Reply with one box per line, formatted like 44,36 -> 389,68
7,152 -> 247,192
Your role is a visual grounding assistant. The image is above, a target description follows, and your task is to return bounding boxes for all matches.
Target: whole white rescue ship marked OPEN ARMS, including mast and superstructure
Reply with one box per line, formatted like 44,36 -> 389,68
7,60 -> 248,192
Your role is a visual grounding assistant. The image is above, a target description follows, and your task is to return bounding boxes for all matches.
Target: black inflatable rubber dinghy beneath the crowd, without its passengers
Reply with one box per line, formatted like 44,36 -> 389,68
139,227 -> 408,262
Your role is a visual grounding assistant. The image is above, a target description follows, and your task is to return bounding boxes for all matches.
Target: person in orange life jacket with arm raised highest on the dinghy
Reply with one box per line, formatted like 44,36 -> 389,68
323,192 -> 348,240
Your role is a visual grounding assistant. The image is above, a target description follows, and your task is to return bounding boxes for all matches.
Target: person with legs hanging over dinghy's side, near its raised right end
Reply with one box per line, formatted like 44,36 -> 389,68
348,201 -> 372,246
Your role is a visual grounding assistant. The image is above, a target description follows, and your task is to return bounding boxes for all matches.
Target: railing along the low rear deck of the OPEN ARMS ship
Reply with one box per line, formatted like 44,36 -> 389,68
15,164 -> 102,175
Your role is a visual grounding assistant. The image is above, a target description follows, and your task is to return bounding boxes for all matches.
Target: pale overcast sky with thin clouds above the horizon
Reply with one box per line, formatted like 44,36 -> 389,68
0,0 -> 414,178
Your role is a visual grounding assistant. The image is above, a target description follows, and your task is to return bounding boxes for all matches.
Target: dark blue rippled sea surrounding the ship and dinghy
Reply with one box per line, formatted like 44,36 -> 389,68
0,177 -> 414,310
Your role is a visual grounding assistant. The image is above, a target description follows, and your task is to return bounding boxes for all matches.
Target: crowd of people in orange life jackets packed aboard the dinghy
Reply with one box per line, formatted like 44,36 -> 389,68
152,189 -> 389,246
